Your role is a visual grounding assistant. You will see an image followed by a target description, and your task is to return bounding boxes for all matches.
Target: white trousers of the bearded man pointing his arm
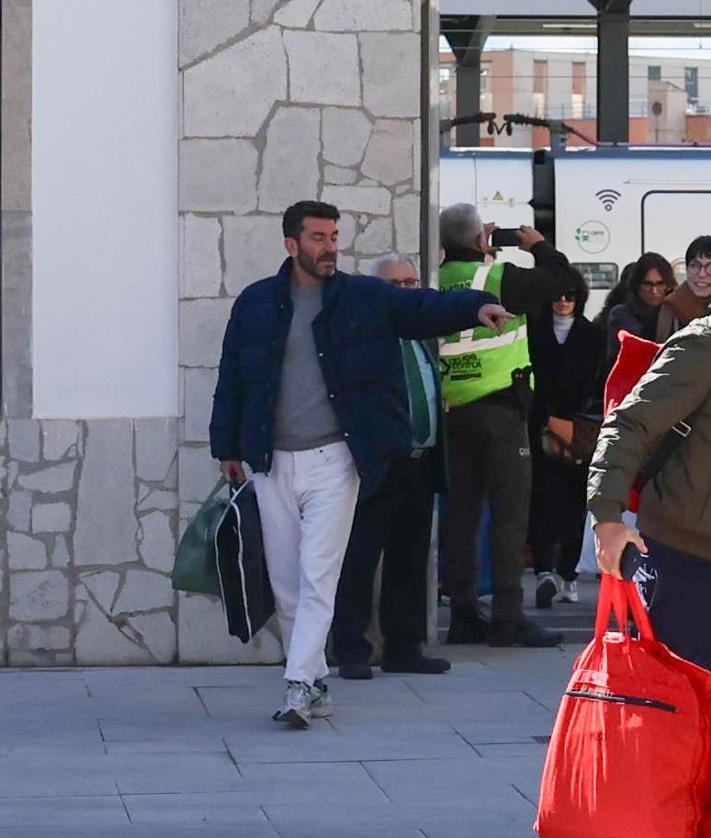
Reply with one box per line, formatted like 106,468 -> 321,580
253,442 -> 360,686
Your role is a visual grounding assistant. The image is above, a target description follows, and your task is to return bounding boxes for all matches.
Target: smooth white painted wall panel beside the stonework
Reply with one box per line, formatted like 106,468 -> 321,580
32,0 -> 178,418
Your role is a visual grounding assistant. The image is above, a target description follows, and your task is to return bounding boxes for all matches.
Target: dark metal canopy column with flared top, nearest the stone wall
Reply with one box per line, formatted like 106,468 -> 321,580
440,15 -> 496,146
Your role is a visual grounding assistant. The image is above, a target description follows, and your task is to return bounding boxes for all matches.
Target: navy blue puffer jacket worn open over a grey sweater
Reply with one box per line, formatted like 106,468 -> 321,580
210,259 -> 497,494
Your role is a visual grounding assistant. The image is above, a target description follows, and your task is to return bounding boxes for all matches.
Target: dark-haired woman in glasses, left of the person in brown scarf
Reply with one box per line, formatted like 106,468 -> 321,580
607,252 -> 677,366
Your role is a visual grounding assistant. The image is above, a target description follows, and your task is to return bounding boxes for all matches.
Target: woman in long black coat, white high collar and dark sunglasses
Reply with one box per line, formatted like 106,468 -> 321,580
528,274 -> 604,608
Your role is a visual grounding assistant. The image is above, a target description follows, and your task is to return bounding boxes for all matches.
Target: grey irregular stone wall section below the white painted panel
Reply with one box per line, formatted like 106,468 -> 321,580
0,419 -> 177,666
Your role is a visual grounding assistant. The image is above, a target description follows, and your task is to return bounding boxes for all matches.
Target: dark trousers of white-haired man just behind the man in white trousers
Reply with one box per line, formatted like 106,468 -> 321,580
332,449 -> 434,663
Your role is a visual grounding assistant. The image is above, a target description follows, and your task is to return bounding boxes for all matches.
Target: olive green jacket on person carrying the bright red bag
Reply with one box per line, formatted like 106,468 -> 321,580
588,315 -> 711,561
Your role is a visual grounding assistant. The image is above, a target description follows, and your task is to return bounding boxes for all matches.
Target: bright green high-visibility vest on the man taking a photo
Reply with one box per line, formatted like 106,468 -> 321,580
439,262 -> 530,407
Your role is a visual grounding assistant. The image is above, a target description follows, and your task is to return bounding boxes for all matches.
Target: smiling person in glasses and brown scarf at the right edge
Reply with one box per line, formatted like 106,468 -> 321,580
656,236 -> 711,343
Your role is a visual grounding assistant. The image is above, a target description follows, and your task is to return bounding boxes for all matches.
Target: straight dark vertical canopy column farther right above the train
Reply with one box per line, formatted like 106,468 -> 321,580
590,0 -> 631,143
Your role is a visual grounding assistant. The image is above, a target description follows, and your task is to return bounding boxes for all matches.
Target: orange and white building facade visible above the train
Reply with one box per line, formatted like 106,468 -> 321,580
439,49 -> 711,148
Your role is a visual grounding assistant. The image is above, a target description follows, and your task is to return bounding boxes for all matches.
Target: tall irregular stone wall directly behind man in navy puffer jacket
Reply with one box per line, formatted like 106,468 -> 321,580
178,0 -> 420,662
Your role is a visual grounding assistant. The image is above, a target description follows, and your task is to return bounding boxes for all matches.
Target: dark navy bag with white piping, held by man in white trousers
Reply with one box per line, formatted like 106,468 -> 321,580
215,482 -> 274,643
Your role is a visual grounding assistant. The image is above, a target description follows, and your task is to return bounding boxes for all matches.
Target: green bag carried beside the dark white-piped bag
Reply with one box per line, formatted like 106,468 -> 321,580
173,477 -> 229,596
